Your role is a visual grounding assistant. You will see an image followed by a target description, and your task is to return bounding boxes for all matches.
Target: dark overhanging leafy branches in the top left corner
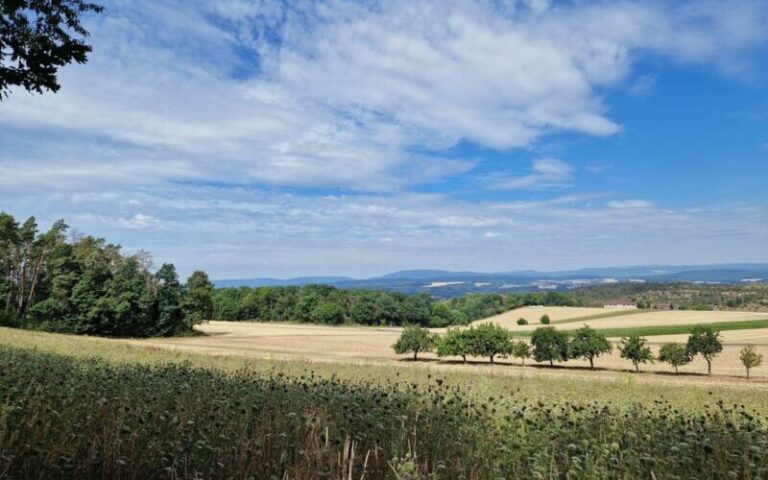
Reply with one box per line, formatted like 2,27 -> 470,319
0,0 -> 103,100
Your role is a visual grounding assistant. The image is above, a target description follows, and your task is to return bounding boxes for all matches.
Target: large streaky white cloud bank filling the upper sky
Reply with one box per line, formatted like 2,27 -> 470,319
0,0 -> 768,190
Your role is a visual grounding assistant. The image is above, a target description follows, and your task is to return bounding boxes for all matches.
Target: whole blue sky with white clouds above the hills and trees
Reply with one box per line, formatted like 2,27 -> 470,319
0,0 -> 768,279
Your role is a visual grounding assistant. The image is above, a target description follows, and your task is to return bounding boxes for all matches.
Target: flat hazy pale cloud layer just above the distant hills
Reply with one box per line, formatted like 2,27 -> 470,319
3,185 -> 768,278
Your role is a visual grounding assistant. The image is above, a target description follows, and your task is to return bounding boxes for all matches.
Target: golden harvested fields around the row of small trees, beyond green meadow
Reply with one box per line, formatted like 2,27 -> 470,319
6,307 -> 768,389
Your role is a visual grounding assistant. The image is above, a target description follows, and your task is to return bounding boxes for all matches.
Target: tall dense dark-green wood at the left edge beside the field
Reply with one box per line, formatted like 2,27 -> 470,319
0,212 -> 213,337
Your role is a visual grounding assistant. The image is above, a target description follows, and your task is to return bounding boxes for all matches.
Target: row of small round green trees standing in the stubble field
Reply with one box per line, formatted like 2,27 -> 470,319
392,323 -> 763,378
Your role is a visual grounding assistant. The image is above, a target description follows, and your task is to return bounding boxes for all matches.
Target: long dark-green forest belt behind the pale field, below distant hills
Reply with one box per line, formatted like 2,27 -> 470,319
213,285 -> 578,327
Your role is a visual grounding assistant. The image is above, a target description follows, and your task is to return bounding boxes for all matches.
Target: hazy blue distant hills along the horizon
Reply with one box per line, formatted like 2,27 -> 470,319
214,263 -> 768,297
